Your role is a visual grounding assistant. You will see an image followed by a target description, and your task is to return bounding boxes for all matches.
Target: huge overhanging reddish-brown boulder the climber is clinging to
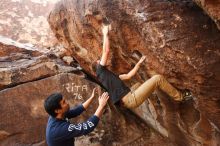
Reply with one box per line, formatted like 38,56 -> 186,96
48,0 -> 220,146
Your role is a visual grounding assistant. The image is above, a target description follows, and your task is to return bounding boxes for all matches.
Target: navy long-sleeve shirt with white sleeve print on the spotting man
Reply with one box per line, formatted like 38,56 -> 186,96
46,105 -> 99,146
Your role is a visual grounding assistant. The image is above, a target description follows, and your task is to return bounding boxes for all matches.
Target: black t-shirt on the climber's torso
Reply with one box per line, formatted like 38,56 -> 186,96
96,64 -> 130,104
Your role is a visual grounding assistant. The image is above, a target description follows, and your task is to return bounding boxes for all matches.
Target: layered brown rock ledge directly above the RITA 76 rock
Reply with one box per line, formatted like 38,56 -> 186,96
0,37 -> 77,89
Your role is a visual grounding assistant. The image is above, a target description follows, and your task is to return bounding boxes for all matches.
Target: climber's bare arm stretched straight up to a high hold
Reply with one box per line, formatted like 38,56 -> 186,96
100,26 -> 110,66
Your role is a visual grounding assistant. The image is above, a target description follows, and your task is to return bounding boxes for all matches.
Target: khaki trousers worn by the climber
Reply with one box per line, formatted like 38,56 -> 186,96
122,75 -> 183,108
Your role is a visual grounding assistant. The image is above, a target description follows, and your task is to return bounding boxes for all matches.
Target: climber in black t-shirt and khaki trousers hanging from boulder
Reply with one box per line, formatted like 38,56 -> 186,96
92,25 -> 192,108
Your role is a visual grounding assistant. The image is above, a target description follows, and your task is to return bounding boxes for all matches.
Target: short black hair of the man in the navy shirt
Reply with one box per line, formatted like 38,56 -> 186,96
44,93 -> 63,117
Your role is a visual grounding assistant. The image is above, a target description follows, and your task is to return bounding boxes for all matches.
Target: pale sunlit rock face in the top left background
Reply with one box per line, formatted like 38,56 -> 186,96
0,0 -> 58,47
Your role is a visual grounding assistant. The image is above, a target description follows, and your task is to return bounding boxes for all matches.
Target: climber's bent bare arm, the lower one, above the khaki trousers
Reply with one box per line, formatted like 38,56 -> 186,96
119,56 -> 146,80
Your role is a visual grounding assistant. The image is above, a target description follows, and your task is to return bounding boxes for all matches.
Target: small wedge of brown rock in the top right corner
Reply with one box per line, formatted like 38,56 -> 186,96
194,0 -> 220,29
